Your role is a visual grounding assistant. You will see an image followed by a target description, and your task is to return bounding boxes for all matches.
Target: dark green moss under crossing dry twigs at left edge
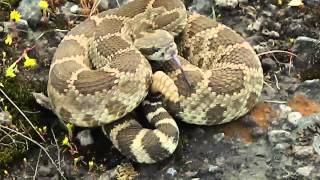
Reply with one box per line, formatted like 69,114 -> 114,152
0,75 -> 44,167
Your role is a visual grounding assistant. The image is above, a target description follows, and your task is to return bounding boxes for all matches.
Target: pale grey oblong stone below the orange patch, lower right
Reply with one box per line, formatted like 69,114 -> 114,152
268,130 -> 294,145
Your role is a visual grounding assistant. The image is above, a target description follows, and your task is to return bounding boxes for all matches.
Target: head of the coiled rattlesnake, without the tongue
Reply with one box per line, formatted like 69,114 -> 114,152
134,30 -> 178,61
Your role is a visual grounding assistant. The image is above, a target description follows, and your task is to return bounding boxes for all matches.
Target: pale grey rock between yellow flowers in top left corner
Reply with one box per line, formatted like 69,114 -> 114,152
17,0 -> 42,29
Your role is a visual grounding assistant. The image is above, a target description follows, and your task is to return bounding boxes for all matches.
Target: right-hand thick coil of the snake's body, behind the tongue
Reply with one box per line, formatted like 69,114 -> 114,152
155,13 -> 263,125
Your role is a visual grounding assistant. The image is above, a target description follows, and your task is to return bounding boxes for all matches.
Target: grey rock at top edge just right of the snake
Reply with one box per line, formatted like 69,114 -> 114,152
189,0 -> 213,16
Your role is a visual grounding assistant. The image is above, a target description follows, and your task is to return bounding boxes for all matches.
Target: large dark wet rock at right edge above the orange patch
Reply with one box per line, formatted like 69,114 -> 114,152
292,36 -> 320,80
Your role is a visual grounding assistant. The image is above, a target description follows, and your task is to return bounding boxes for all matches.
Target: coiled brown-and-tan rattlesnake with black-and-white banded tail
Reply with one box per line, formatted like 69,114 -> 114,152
47,0 -> 263,163
